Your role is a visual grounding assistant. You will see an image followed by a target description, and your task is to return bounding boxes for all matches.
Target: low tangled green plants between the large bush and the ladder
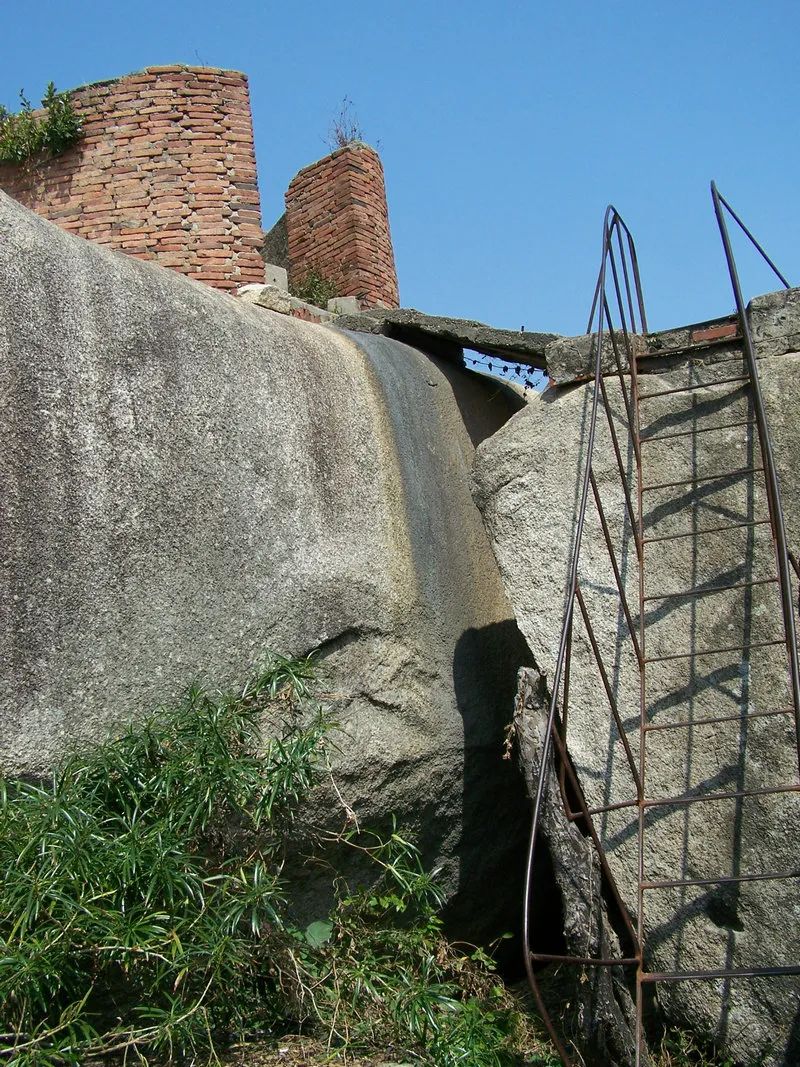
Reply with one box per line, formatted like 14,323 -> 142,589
291,824 -> 555,1067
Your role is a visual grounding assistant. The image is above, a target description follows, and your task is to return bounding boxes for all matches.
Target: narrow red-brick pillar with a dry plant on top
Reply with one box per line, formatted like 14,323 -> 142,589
286,142 -> 399,307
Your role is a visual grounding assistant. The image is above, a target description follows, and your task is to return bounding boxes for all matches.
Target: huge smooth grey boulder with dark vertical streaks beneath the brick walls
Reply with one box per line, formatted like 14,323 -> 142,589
0,194 -> 528,938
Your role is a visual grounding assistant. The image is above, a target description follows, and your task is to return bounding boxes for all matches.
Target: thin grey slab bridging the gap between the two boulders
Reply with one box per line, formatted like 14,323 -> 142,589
337,308 -> 558,370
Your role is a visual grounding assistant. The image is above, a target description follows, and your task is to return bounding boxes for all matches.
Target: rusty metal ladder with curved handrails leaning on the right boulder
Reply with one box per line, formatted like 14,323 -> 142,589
523,194 -> 800,1067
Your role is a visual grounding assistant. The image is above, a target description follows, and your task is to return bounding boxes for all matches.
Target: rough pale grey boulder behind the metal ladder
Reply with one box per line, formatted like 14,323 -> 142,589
474,352 -> 800,1065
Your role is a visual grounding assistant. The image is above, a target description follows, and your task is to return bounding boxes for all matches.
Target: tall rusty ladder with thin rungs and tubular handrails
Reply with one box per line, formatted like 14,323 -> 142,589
524,184 -> 800,1067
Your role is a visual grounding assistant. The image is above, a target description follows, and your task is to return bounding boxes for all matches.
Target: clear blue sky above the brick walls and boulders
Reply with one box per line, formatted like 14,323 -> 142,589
0,0 -> 800,333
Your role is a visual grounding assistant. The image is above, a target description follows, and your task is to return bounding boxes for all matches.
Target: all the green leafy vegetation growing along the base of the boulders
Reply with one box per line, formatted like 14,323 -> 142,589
0,656 -> 555,1067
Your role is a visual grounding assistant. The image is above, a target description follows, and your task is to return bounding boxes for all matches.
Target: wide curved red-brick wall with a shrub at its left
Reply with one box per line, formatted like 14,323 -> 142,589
0,66 -> 263,289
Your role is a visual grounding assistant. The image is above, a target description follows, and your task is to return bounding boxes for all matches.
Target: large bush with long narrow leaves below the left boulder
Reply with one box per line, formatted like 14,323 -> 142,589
0,657 -> 329,1067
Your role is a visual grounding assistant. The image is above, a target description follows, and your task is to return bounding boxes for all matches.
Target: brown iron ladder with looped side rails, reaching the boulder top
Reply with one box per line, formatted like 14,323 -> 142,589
523,192 -> 800,1067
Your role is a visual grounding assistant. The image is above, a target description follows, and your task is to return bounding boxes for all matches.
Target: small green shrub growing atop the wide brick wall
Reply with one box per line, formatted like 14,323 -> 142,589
0,82 -> 81,164
